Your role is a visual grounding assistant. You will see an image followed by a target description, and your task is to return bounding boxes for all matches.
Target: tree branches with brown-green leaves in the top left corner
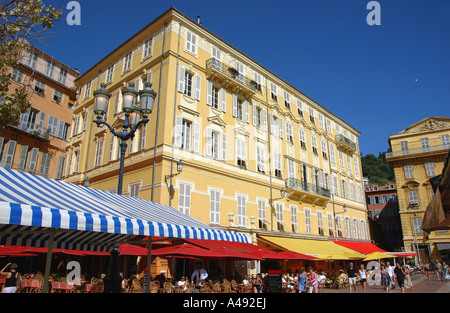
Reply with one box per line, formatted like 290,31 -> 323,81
0,0 -> 62,131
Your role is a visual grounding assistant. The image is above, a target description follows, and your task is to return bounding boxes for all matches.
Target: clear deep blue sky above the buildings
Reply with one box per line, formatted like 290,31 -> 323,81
36,0 -> 450,155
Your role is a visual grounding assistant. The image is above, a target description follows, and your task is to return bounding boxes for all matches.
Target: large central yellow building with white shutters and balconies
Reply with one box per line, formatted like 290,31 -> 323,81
65,9 -> 370,258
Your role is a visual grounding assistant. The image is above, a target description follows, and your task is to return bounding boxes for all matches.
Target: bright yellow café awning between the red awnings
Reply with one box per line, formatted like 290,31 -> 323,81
260,236 -> 366,260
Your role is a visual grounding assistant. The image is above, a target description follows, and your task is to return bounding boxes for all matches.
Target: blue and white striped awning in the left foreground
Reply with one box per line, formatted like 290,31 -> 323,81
0,168 -> 249,251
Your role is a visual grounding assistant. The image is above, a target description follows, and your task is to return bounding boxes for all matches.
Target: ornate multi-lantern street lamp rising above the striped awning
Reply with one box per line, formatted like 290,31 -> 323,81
94,82 -> 156,195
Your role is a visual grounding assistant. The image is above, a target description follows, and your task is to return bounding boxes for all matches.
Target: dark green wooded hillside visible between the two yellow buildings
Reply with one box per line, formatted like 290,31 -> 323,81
361,152 -> 395,186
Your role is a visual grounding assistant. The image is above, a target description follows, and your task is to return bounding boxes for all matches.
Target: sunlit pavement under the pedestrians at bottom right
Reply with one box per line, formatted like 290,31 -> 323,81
320,274 -> 450,293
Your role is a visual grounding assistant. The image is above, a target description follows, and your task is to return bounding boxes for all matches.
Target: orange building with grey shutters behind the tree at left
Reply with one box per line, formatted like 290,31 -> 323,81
0,47 -> 80,179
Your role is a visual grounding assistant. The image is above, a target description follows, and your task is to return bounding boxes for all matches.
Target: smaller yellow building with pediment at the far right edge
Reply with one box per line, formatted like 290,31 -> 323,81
386,117 -> 450,263
